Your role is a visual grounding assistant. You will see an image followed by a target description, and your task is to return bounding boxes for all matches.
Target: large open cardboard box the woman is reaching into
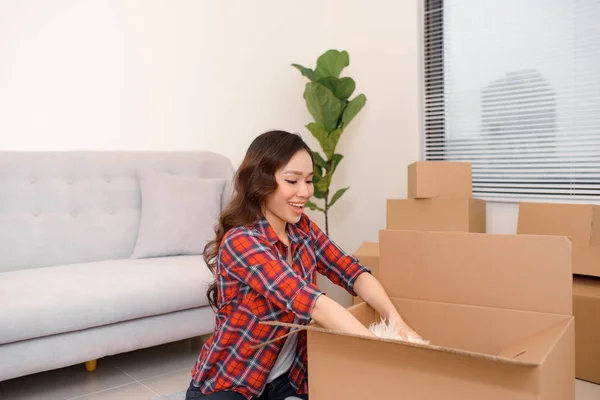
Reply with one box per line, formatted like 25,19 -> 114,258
273,231 -> 575,400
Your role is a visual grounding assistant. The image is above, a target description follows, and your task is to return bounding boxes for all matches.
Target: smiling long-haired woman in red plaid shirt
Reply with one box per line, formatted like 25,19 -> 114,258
186,131 -> 418,400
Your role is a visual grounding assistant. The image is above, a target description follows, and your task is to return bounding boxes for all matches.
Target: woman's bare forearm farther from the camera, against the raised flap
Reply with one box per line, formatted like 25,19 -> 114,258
354,273 -> 421,339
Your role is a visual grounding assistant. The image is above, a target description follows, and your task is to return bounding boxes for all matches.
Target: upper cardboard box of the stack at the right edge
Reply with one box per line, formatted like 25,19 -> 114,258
517,203 -> 600,277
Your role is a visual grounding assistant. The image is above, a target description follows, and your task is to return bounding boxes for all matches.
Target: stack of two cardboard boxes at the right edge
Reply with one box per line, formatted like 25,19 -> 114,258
517,203 -> 600,383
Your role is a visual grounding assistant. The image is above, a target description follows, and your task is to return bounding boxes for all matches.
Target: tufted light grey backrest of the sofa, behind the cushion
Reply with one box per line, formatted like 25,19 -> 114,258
0,152 -> 234,272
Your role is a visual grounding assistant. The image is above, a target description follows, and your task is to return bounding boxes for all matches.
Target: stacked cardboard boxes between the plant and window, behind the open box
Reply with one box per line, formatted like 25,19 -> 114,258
353,161 -> 486,304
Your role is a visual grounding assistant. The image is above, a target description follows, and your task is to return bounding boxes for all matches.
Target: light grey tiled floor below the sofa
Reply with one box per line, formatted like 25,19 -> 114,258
0,338 -> 600,400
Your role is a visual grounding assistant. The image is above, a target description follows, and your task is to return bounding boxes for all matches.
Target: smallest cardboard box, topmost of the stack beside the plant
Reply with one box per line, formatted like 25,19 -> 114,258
408,161 -> 473,199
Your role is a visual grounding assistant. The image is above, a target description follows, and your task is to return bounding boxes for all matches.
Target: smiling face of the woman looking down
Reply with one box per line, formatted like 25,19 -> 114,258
265,150 -> 315,229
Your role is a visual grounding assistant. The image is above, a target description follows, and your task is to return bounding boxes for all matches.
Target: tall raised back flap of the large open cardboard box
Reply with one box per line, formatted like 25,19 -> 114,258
379,230 -> 573,315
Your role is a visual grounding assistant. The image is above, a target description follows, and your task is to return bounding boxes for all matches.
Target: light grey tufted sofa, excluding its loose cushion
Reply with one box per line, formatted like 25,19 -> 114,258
0,152 -> 233,381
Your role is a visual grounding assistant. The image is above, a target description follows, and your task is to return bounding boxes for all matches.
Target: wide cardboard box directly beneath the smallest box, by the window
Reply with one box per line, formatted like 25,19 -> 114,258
386,199 -> 486,233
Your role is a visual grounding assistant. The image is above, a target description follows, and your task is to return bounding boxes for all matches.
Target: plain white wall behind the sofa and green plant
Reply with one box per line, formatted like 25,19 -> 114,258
0,0 -> 421,304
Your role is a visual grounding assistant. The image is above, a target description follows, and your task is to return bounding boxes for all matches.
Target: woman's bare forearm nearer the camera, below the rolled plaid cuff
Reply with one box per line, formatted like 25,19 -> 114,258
311,295 -> 375,337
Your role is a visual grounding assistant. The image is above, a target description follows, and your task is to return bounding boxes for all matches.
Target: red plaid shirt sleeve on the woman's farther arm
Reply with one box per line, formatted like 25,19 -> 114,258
309,220 -> 371,296
